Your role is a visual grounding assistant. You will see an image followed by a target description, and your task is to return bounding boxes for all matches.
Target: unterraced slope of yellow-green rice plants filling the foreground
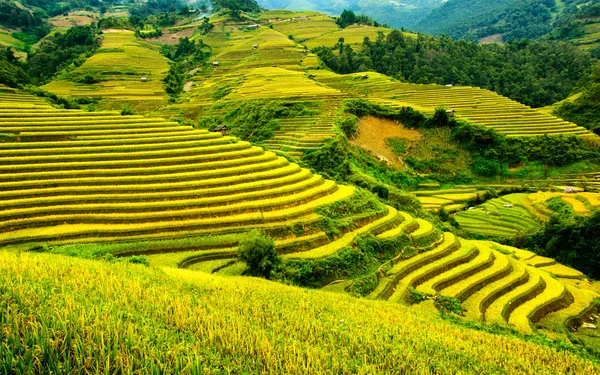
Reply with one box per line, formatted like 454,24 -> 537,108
0,252 -> 600,375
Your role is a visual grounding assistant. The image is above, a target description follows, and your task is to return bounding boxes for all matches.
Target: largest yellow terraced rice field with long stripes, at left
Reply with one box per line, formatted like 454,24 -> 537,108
0,90 -> 412,265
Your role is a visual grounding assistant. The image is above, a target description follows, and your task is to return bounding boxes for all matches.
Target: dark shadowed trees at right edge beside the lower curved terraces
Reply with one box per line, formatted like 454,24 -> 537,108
525,199 -> 600,279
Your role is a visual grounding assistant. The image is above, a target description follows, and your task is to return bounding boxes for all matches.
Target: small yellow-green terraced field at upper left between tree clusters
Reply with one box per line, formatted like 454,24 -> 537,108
43,30 -> 169,109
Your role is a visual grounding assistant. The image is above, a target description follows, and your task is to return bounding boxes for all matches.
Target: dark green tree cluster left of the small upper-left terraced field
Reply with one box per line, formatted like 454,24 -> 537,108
26,25 -> 100,84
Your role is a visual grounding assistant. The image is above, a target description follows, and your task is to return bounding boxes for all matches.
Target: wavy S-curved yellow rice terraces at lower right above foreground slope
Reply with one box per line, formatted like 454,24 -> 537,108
369,230 -> 597,333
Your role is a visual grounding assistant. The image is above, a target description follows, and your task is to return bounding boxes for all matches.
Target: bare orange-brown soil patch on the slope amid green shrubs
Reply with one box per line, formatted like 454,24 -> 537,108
350,117 -> 422,168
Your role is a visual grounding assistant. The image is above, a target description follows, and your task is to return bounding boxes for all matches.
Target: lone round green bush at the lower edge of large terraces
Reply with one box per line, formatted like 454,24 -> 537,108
238,229 -> 281,279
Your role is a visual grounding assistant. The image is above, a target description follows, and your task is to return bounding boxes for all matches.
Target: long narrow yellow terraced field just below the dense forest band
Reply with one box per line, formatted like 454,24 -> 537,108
311,71 -> 597,139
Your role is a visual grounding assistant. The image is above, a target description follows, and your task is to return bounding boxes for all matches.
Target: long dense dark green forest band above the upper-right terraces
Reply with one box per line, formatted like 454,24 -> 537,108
315,30 -> 592,107
